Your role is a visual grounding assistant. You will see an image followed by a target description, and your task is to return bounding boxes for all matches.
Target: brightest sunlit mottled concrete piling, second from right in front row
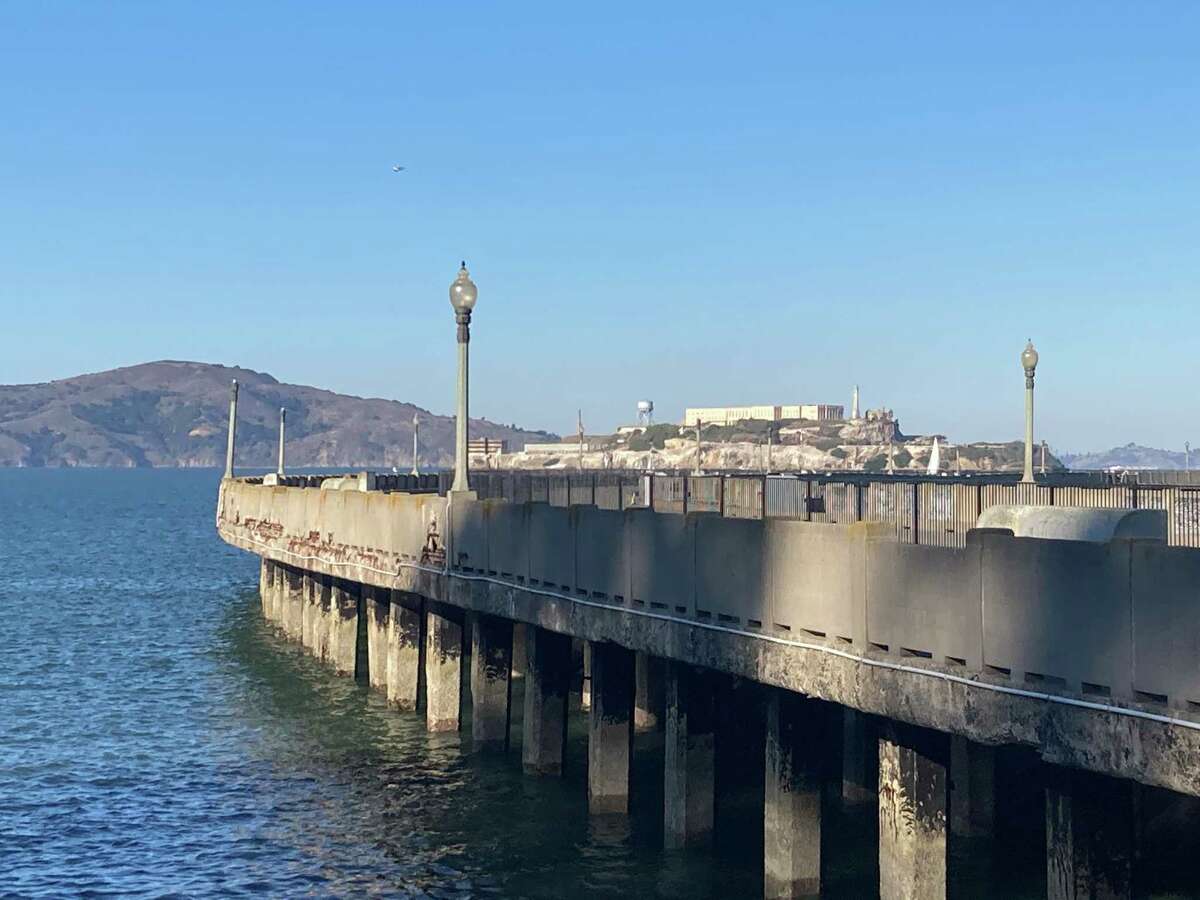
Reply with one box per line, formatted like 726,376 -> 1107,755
880,722 -> 949,900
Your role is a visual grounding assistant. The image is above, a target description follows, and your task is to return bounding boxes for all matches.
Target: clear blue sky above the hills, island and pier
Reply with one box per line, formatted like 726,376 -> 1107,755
0,0 -> 1200,450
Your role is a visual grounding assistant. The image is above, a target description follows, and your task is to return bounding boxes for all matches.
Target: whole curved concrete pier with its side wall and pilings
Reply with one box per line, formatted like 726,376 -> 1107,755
217,474 -> 1200,900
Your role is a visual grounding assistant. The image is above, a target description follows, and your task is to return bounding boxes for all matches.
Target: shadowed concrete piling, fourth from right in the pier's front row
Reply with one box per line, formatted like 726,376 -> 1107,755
662,654 -> 716,850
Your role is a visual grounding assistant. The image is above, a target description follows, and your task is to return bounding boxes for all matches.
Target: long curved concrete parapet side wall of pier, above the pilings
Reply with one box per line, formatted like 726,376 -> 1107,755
218,481 -> 1200,794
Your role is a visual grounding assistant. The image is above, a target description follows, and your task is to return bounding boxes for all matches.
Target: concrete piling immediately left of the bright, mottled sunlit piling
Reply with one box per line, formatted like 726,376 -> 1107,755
763,689 -> 829,900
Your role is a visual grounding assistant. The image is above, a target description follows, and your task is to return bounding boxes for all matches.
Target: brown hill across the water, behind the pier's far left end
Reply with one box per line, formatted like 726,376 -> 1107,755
0,361 -> 553,468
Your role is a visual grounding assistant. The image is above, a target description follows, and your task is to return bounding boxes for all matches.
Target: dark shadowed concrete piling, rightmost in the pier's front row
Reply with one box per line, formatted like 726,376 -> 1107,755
1046,769 -> 1135,900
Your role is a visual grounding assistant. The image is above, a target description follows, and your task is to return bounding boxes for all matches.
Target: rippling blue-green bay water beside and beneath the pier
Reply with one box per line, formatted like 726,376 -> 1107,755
9,470 -> 1190,900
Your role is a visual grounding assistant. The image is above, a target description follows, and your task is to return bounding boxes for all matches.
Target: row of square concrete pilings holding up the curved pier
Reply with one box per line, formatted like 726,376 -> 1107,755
259,559 -> 1161,900
